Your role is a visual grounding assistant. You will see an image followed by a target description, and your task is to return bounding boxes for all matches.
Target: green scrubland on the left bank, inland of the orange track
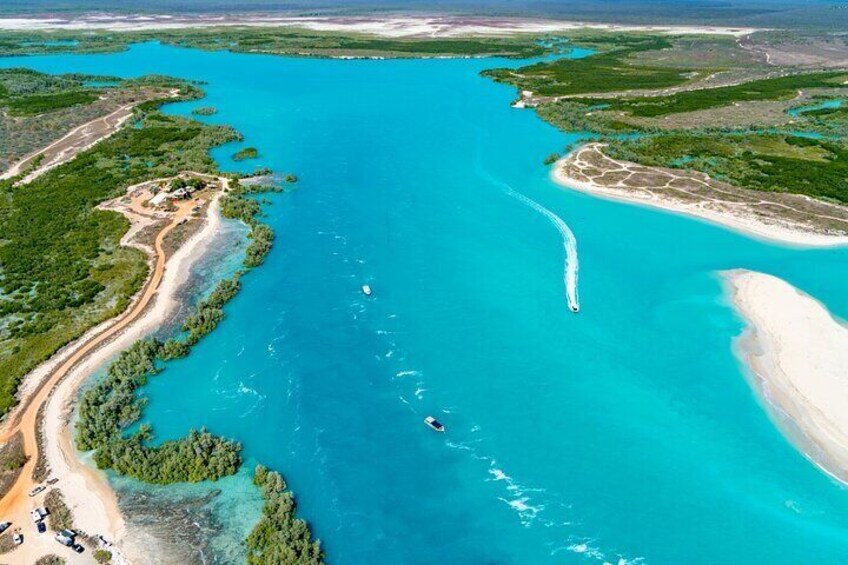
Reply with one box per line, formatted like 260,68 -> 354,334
0,80 -> 238,412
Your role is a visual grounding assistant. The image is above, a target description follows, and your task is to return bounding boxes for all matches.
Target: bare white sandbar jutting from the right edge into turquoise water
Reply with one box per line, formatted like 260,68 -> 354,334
722,270 -> 848,484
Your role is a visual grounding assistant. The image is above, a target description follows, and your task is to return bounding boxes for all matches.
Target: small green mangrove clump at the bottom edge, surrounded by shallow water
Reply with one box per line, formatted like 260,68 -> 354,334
246,465 -> 324,565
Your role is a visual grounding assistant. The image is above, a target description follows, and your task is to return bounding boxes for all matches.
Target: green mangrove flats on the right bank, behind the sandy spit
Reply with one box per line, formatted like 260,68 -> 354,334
483,30 -> 848,204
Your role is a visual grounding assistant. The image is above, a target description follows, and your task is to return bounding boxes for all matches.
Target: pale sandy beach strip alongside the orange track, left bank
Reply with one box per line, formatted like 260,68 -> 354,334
3,192 -> 223,564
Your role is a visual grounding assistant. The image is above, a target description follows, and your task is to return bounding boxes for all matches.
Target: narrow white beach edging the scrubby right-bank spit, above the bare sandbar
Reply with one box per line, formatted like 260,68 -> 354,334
551,144 -> 848,247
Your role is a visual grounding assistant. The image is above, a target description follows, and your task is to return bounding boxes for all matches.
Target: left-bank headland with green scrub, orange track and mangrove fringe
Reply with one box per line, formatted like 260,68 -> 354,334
0,65 -> 323,563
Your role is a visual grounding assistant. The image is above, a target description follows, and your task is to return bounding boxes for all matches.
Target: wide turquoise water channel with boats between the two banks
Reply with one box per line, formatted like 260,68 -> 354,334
0,44 -> 848,565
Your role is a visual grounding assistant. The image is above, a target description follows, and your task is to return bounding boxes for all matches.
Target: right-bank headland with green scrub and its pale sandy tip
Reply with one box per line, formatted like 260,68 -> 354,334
484,28 -> 848,245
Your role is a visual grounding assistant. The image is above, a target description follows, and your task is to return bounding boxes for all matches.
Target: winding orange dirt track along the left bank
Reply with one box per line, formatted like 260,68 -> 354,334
0,202 -> 191,532
